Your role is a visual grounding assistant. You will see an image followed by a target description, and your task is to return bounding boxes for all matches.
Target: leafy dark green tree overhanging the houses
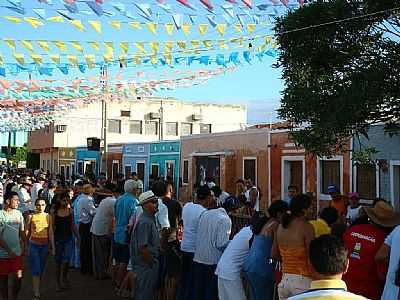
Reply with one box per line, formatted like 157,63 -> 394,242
275,0 -> 400,155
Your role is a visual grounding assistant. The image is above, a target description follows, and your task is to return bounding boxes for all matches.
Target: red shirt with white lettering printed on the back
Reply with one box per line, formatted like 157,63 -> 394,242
343,224 -> 386,300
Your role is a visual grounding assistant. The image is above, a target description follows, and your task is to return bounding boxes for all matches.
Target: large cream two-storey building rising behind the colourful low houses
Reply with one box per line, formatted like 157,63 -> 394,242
28,97 -> 247,173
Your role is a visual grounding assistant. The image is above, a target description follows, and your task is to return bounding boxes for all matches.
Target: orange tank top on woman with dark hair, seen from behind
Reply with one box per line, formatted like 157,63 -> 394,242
279,247 -> 310,277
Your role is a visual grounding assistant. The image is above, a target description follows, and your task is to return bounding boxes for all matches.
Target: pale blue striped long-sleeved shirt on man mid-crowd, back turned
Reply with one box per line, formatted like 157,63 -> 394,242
193,208 -> 232,265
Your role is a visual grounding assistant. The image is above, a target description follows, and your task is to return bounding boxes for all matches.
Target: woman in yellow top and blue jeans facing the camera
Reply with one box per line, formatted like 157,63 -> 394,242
26,198 -> 54,300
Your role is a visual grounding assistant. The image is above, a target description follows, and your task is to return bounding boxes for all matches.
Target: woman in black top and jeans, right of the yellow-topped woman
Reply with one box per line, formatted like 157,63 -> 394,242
53,193 -> 79,291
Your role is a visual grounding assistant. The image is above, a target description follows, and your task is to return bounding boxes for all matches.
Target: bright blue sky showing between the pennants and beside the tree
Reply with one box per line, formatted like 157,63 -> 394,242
0,0 -> 290,123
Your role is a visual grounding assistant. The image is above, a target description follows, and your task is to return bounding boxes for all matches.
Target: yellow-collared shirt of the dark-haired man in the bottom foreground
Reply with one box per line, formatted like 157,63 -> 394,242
288,280 -> 367,300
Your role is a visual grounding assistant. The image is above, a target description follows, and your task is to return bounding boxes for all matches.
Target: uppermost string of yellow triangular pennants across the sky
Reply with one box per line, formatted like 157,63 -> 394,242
1,16 -> 272,36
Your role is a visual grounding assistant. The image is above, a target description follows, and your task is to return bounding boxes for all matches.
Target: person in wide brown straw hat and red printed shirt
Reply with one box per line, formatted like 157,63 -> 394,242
343,201 -> 400,300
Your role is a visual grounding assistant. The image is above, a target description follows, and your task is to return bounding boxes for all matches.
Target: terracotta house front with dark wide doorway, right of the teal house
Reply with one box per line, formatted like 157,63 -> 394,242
179,129 -> 269,210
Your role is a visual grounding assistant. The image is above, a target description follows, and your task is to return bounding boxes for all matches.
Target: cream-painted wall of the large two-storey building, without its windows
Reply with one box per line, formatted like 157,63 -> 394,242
28,98 -> 247,150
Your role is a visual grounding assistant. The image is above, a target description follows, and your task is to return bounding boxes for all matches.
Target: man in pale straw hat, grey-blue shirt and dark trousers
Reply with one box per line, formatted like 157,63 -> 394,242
130,191 -> 160,300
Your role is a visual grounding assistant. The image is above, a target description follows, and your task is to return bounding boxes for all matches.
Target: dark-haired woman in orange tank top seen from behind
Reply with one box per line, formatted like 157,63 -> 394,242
272,194 -> 314,300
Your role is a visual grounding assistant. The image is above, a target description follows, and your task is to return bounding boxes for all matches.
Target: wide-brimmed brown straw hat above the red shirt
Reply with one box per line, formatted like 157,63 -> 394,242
364,201 -> 400,227
